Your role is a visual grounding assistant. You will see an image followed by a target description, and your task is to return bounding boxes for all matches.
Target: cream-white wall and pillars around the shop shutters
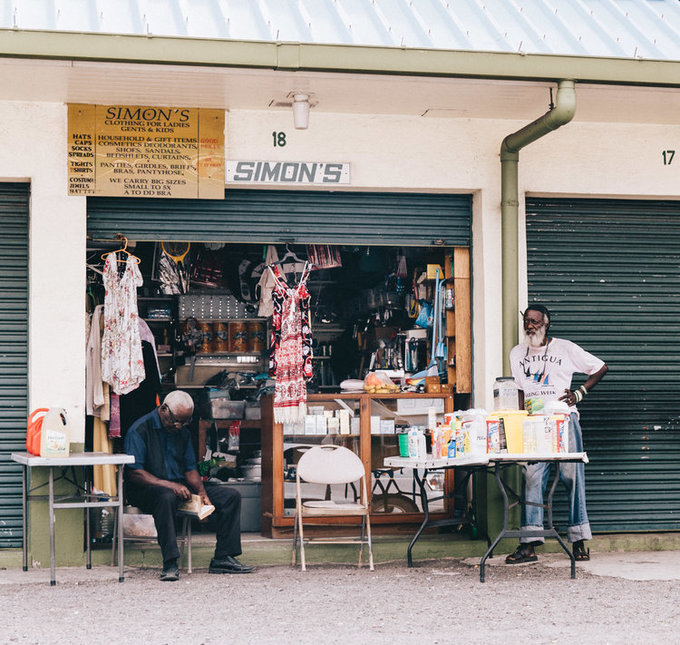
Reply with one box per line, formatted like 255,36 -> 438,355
0,102 -> 680,430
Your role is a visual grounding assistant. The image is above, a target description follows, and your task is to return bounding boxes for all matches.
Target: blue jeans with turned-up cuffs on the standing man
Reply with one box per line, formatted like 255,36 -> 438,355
520,412 -> 593,543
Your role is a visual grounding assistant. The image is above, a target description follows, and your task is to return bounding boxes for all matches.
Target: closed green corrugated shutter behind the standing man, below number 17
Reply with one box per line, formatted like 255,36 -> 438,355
526,198 -> 680,532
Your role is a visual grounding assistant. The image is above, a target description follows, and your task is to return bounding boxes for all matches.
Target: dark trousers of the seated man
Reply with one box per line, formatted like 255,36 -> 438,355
125,482 -> 241,562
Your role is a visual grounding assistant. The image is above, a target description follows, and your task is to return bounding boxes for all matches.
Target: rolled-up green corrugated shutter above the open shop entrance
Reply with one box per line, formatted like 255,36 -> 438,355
87,189 -> 471,246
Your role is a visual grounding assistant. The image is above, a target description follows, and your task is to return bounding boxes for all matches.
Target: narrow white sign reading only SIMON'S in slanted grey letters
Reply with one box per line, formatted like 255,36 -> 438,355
227,161 -> 349,186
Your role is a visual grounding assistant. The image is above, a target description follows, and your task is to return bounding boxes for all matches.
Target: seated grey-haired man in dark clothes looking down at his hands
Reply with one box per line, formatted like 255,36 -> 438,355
125,391 -> 253,581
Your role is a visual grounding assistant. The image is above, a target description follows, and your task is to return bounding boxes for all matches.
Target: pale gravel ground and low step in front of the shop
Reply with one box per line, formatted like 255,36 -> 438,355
0,534 -> 680,645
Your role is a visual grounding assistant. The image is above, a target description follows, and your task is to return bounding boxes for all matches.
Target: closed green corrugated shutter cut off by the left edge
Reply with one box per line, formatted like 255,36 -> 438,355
0,183 -> 29,548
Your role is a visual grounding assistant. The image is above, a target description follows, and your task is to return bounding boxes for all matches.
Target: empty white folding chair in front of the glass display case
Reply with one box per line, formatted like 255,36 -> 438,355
292,445 -> 374,571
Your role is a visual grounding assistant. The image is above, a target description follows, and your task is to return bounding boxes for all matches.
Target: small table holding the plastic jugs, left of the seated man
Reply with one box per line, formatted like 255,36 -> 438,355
11,452 -> 135,585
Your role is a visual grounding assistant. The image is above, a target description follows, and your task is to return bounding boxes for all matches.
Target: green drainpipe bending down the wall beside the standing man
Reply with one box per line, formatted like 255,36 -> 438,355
501,80 -> 576,376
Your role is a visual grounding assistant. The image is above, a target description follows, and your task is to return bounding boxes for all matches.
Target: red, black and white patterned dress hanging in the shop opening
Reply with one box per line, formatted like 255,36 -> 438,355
269,265 -> 312,423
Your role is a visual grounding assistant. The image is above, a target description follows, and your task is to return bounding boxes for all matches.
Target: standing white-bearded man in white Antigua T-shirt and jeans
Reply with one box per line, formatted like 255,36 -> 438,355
505,304 -> 607,564
